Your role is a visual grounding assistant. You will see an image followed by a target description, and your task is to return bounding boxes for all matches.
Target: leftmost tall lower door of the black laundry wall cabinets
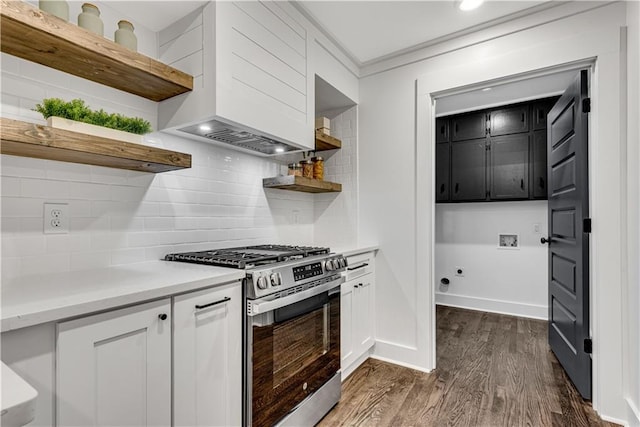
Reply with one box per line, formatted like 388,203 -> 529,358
451,138 -> 487,201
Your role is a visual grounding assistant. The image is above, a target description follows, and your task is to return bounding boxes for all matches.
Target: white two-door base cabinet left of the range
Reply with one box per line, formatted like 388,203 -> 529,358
55,282 -> 242,426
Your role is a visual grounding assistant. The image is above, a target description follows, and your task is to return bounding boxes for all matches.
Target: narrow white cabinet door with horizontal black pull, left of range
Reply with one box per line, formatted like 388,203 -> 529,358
173,283 -> 242,426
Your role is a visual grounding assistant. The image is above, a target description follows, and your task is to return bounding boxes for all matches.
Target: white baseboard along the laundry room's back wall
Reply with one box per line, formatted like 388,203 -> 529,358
436,292 -> 549,320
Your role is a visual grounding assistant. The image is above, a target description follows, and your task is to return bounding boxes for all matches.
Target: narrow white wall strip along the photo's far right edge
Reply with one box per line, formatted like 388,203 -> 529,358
623,1 -> 640,426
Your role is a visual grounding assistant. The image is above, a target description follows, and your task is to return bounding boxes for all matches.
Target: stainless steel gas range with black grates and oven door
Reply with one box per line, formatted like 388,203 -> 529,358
165,245 -> 347,426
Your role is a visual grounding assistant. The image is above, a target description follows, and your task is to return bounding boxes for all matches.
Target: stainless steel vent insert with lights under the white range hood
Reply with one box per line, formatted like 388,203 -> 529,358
178,120 -> 301,156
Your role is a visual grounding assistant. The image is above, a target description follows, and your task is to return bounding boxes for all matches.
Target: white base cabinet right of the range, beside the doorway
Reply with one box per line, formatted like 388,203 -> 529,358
340,252 -> 375,378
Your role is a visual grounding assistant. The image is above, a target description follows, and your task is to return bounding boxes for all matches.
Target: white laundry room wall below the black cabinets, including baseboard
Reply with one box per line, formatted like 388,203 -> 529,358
434,201 -> 548,320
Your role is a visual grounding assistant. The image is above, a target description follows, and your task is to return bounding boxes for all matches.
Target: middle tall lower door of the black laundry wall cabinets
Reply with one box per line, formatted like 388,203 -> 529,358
491,134 -> 529,200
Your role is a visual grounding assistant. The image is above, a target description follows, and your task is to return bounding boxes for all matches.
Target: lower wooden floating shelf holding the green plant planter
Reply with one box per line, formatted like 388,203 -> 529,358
0,118 -> 191,173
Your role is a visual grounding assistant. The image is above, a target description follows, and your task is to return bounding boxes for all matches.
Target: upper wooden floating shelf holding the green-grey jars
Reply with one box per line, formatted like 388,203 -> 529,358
0,0 -> 193,101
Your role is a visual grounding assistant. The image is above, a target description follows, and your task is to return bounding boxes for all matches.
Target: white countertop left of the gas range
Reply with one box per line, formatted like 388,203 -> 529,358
1,261 -> 245,332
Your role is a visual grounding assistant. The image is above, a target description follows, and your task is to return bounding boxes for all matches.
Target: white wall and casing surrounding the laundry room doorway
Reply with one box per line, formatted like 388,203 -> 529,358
359,2 -> 638,421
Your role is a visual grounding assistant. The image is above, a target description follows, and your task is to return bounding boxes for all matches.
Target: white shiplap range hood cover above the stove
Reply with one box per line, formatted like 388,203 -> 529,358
158,1 -> 314,149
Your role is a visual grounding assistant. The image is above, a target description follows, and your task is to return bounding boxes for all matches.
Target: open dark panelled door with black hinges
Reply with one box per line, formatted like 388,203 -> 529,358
547,70 -> 592,399
